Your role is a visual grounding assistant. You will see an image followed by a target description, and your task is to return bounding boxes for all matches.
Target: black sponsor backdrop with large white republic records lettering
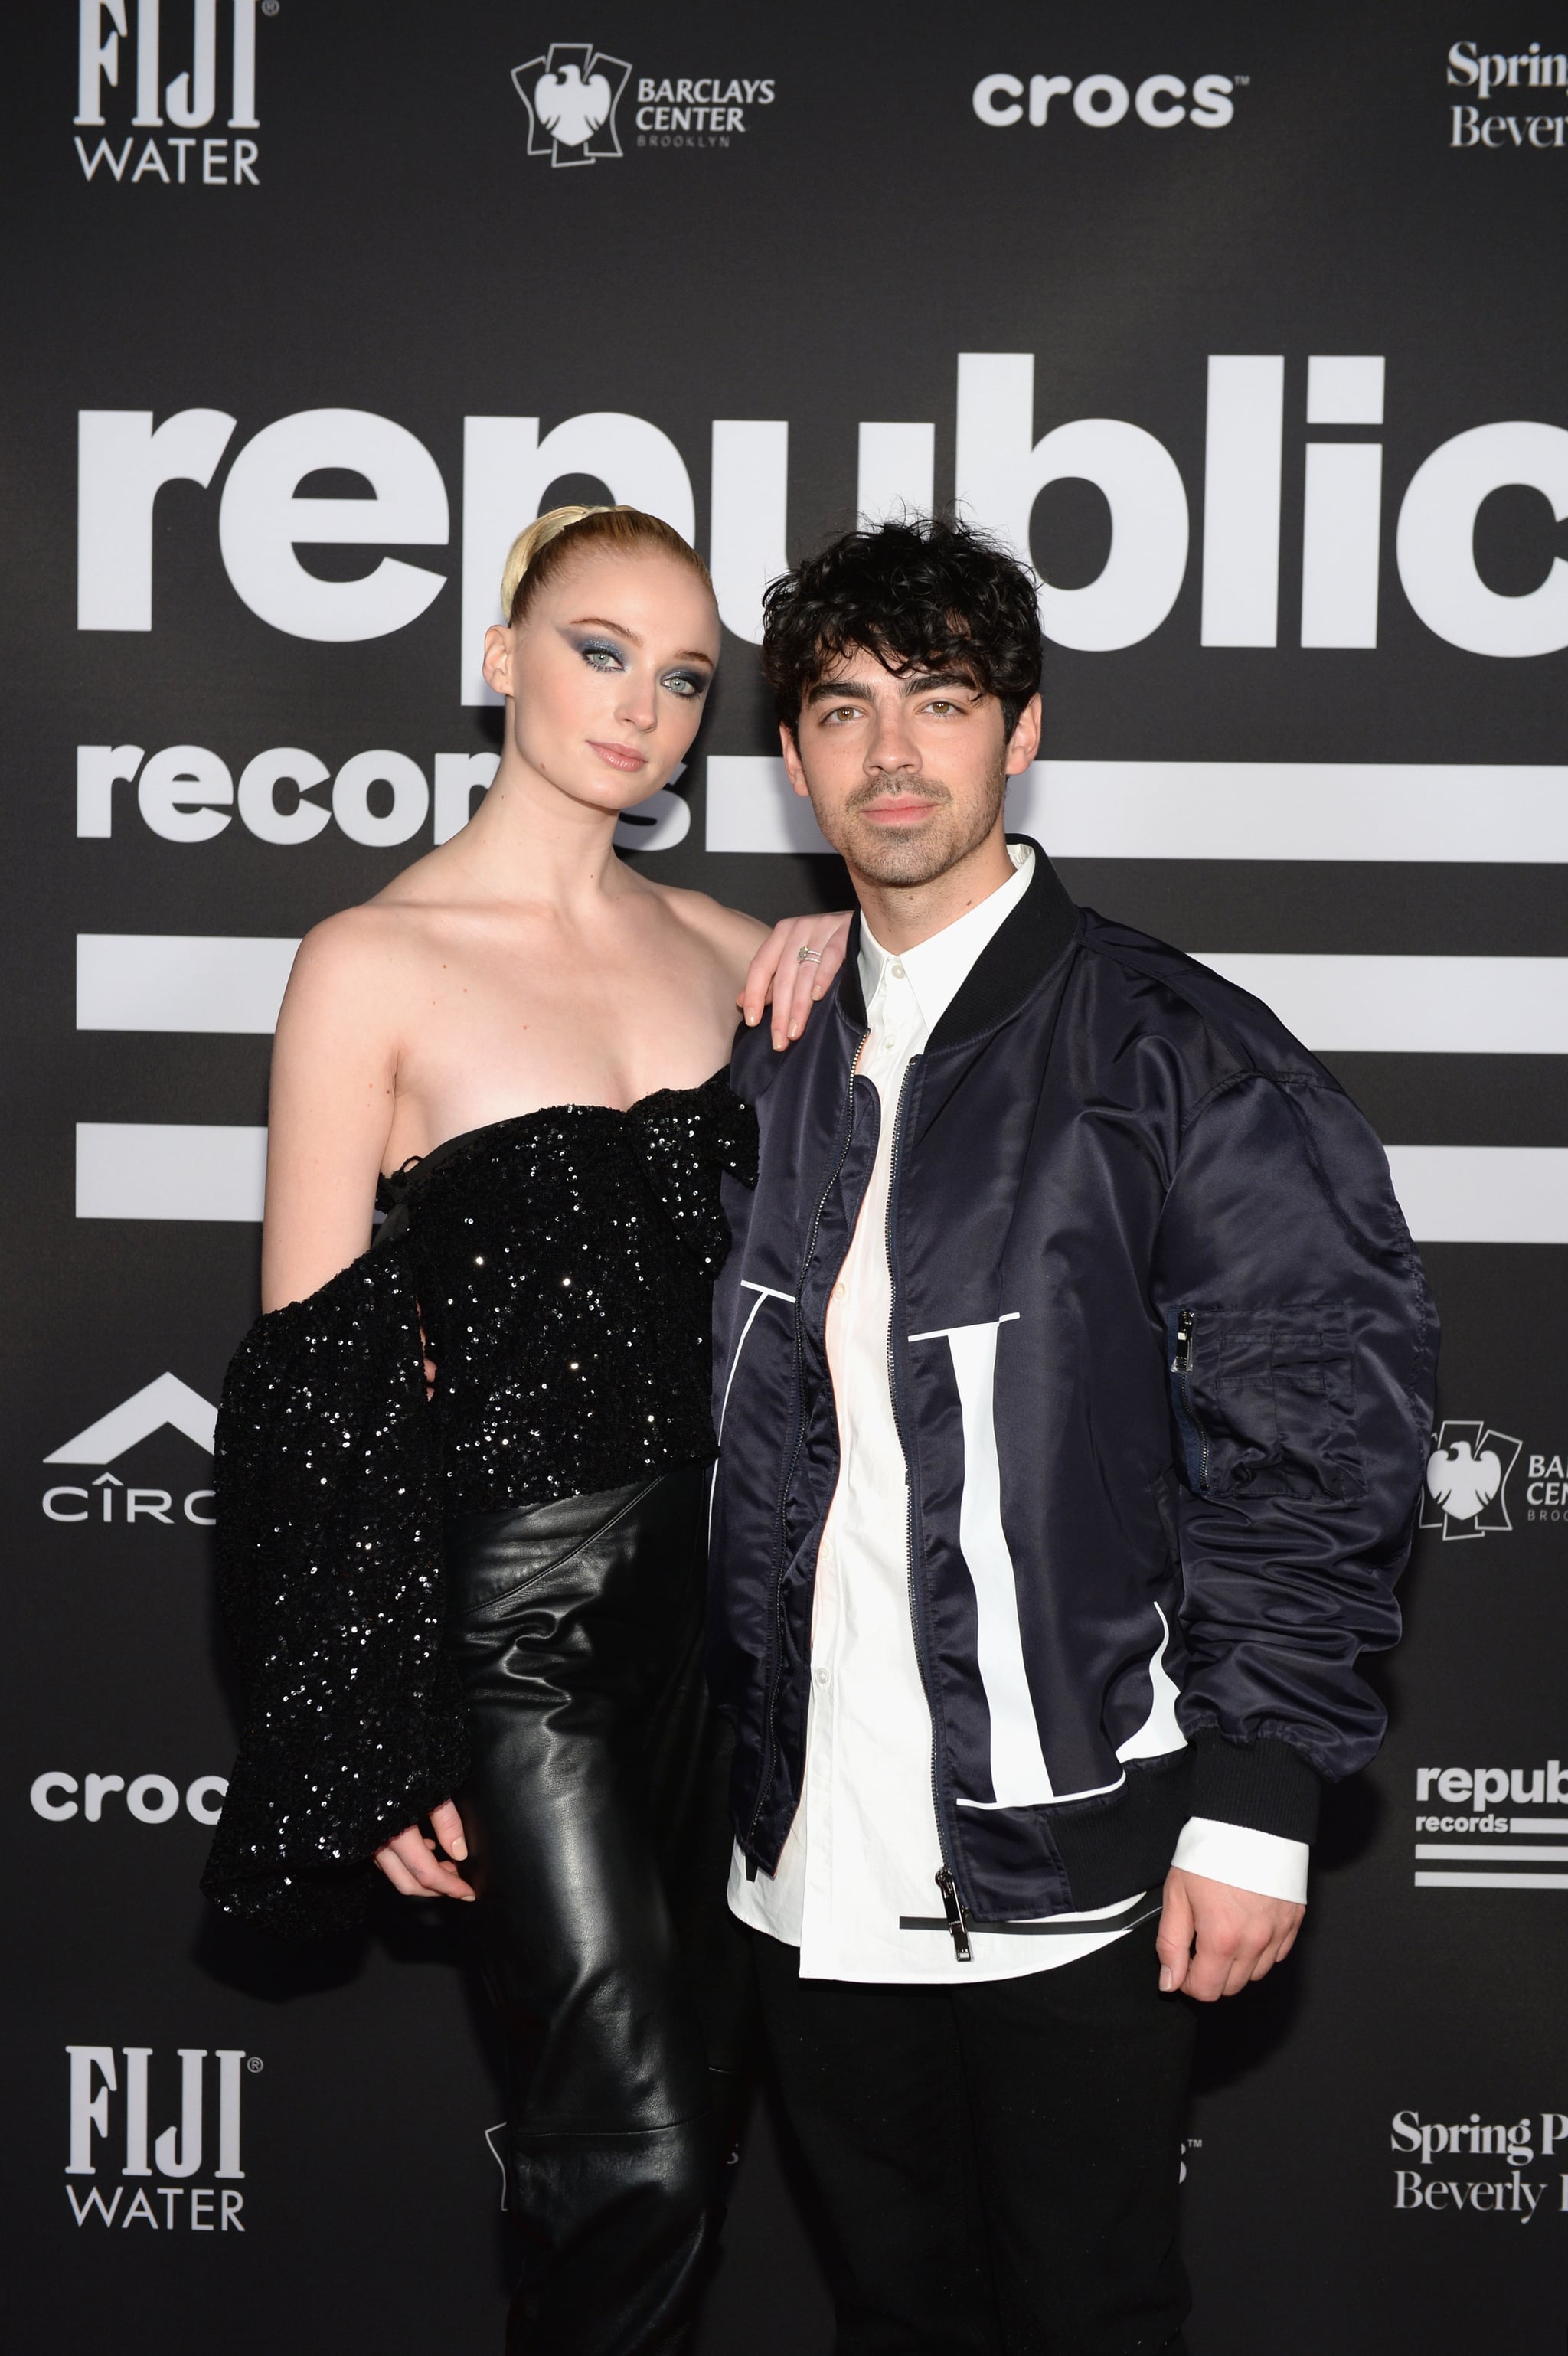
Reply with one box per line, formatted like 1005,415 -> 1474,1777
11,0 -> 1568,2356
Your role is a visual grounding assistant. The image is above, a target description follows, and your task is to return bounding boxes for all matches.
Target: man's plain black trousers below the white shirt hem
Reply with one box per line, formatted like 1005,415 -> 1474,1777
751,1923 -> 1194,2356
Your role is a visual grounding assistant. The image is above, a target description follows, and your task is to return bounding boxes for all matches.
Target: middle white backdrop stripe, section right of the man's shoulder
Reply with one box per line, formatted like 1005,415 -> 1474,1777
1194,949 -> 1568,1055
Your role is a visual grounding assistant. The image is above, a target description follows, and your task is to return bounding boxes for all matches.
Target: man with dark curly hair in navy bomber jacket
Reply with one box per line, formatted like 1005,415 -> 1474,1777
711,523 -> 1436,2356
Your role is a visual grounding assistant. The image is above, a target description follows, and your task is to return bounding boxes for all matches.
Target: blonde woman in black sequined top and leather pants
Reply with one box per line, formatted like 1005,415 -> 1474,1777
207,507 -> 843,2356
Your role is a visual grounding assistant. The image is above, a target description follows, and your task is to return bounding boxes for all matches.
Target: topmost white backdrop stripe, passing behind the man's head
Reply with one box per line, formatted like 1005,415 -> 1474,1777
707,754 -> 1568,867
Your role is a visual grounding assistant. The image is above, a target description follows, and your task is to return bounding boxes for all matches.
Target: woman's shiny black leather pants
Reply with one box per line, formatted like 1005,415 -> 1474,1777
445,1466 -> 749,2356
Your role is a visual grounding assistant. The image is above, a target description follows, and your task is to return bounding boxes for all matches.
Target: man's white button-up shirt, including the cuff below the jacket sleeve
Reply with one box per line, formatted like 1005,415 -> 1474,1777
730,844 -> 1307,1984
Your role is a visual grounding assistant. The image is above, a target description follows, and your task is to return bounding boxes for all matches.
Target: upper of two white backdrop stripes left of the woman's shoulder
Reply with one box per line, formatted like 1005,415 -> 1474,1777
75,933 -> 299,1034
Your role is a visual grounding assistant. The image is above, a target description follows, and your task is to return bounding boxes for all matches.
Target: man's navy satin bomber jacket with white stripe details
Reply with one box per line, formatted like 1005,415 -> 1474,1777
709,846 -> 1436,1923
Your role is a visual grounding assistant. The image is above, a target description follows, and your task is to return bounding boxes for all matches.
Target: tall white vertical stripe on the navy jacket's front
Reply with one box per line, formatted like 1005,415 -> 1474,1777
911,1310 -> 1055,1807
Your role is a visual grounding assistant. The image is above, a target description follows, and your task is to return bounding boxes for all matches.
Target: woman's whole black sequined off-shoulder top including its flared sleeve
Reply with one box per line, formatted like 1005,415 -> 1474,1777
202,1074 -> 756,1934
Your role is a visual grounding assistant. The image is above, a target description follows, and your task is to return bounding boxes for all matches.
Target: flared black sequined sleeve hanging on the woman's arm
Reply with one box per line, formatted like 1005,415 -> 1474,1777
202,1244 -> 464,1936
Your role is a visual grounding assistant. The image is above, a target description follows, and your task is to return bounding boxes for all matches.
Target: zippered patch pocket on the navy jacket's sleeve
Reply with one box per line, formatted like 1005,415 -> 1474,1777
1170,1301 -> 1366,1501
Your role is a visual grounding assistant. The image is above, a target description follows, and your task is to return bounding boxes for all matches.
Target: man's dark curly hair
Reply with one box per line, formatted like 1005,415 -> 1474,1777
763,516 -> 1043,735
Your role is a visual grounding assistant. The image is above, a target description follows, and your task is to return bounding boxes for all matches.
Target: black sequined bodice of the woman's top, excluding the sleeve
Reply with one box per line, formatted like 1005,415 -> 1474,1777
377,1074 -> 756,1515
